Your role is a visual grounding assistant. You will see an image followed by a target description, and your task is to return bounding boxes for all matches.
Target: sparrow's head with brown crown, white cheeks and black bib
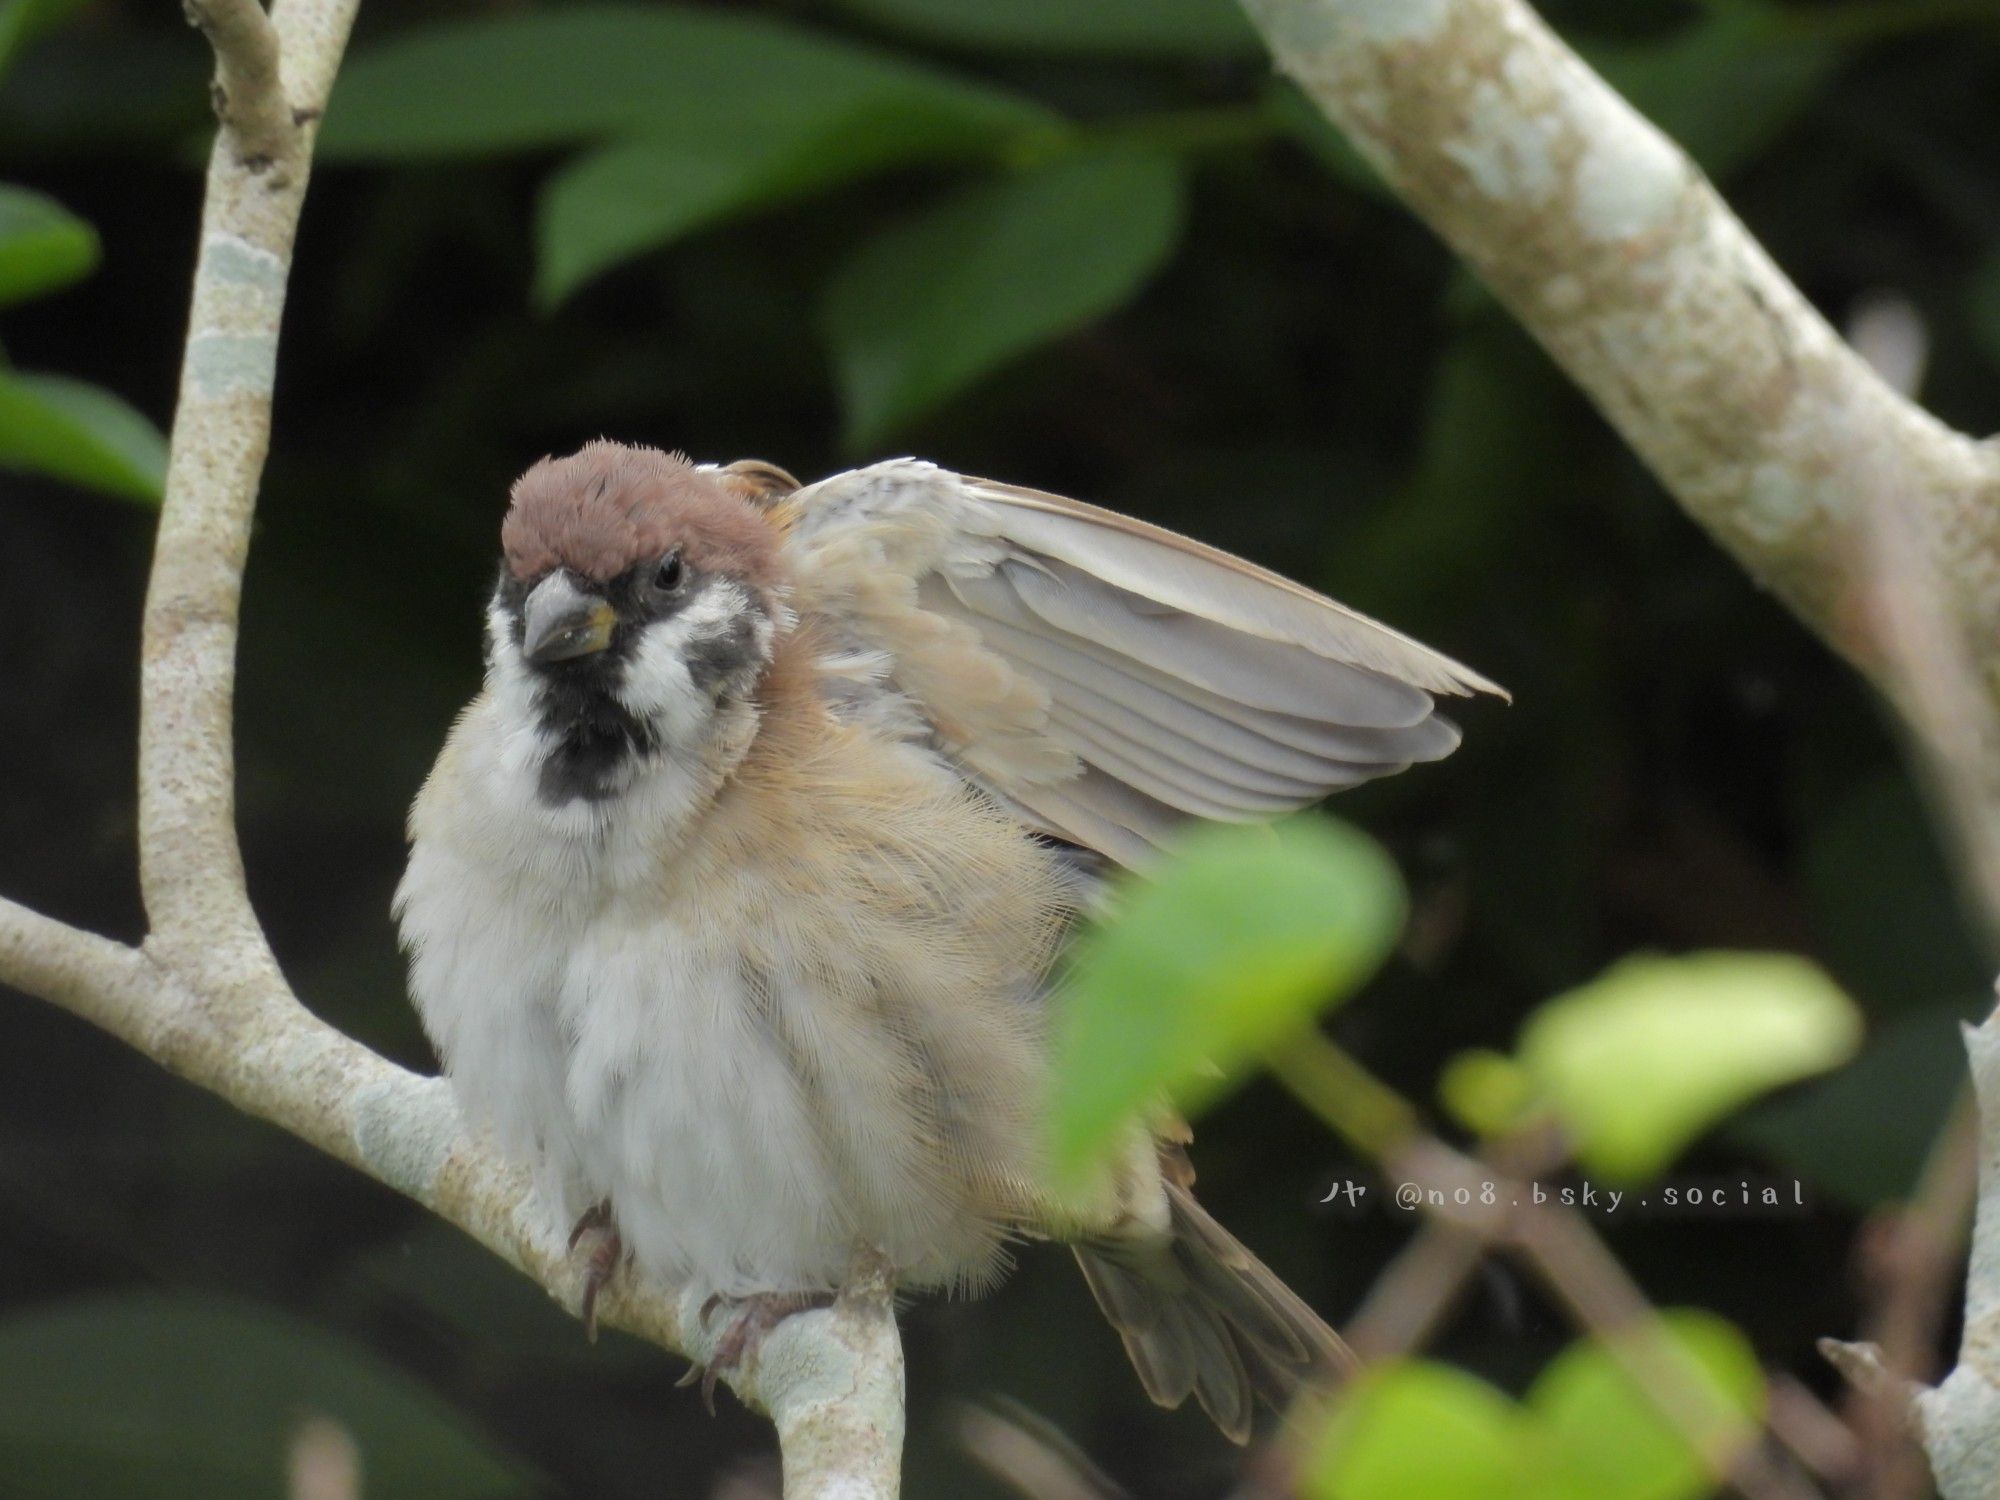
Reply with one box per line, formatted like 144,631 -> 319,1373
486,442 -> 786,802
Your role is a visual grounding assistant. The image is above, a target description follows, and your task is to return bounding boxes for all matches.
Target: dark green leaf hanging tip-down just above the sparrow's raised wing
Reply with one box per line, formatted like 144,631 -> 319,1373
822,150 -> 1182,450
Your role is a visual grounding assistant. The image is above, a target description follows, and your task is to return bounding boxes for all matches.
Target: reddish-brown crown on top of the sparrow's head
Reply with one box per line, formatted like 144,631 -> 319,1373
500,440 -> 778,590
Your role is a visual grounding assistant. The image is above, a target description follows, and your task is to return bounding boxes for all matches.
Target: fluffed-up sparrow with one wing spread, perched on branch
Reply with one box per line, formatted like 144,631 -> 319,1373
396,442 -> 1494,1440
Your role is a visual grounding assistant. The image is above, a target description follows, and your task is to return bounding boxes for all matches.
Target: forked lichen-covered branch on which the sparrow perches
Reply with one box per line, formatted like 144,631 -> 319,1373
0,0 -> 904,1500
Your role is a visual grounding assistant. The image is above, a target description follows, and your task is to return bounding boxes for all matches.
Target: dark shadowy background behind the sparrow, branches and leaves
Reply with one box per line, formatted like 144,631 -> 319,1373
0,0 -> 2000,1500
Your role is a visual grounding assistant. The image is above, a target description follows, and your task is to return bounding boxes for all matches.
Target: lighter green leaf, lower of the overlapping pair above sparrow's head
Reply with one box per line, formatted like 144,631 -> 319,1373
536,108 -> 1016,306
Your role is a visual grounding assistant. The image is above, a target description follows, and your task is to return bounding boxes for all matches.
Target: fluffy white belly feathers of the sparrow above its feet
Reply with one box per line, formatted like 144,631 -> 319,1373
400,842 -> 1006,1296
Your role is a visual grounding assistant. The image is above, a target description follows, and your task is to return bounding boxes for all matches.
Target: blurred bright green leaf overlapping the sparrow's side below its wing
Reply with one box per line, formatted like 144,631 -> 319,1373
1052,818 -> 1404,1180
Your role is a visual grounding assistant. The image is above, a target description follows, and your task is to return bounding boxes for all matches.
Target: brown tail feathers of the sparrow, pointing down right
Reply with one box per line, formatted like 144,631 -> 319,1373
1076,1184 -> 1356,1442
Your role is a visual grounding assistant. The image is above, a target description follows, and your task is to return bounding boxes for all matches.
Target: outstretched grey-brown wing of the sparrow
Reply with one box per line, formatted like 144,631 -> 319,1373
774,458 -> 1504,864
